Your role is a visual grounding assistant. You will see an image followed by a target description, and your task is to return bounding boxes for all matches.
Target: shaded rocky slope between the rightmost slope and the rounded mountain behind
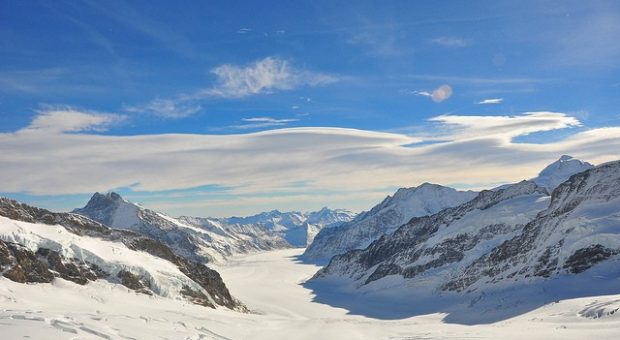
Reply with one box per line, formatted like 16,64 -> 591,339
316,181 -> 549,287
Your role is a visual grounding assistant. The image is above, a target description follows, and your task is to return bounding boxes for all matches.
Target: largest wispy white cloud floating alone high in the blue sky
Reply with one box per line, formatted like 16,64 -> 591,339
201,57 -> 337,98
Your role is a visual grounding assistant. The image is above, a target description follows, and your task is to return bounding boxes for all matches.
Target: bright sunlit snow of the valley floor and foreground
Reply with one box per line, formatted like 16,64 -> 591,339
0,249 -> 620,340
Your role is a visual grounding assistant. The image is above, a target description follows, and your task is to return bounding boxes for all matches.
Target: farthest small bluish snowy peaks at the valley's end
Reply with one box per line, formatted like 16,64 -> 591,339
217,207 -> 355,247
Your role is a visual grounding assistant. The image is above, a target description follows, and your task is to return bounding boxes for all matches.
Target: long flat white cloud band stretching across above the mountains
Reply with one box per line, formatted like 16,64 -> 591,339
0,110 -> 620,215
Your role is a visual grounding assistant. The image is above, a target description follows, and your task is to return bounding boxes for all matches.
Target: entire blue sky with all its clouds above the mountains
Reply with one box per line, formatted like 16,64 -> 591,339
0,0 -> 620,217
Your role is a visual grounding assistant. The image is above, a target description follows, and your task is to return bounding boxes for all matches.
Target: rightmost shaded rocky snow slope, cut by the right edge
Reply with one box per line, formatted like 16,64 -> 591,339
443,161 -> 620,291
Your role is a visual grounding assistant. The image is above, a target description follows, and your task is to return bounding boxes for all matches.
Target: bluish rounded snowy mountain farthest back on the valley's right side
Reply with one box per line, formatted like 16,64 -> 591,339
303,183 -> 477,261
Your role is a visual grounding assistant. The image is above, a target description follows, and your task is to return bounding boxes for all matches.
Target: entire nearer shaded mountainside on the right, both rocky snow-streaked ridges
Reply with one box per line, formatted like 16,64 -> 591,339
314,161 -> 620,300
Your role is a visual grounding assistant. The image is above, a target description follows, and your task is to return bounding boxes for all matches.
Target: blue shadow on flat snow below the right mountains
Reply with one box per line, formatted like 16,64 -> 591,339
294,257 -> 620,325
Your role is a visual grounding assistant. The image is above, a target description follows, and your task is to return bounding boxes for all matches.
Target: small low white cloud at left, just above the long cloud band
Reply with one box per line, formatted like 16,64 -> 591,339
21,107 -> 125,133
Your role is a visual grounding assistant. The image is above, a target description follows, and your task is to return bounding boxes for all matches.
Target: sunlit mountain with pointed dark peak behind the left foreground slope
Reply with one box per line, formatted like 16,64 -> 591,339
73,193 -> 289,262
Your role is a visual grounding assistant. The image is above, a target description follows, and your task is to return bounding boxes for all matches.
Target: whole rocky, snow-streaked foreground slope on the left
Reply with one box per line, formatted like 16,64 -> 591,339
0,198 -> 246,310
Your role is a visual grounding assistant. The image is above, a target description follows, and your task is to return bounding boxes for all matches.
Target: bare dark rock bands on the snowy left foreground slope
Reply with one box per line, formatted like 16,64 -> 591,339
0,197 -> 245,310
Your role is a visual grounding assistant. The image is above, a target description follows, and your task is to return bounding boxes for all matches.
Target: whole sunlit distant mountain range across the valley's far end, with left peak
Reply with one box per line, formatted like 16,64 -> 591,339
73,192 -> 354,262
